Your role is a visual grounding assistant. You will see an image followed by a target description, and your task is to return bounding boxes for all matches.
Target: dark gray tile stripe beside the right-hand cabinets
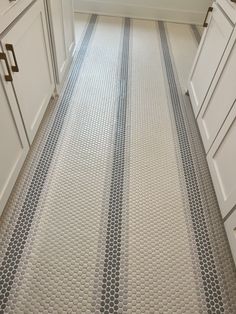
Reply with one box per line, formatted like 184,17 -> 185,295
158,22 -> 225,313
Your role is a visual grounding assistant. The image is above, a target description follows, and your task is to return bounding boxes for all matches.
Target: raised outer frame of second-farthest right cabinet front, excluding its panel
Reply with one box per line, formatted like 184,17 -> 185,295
197,28 -> 236,153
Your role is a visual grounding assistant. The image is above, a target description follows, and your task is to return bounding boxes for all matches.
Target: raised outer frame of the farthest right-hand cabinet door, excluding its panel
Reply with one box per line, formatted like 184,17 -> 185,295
188,3 -> 233,117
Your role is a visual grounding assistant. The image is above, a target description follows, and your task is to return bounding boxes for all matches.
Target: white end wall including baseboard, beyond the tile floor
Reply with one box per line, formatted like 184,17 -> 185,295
74,0 -> 212,24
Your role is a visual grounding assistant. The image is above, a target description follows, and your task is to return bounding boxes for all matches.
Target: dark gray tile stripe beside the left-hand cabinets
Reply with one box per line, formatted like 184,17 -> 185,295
0,15 -> 97,313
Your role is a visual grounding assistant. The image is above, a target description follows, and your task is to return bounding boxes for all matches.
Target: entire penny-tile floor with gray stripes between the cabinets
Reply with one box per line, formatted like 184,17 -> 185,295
0,14 -> 236,314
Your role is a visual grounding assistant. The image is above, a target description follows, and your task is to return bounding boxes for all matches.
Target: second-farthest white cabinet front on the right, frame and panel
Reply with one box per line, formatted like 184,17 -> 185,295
197,31 -> 236,152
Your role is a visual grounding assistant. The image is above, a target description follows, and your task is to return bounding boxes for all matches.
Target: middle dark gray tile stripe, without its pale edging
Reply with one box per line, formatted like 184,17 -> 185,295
100,18 -> 130,314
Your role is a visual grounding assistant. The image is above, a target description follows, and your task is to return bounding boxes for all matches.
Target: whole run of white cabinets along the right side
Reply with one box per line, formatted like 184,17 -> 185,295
188,0 -> 236,263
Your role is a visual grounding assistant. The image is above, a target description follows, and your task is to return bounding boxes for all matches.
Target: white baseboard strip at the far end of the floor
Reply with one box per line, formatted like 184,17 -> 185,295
74,0 -> 206,25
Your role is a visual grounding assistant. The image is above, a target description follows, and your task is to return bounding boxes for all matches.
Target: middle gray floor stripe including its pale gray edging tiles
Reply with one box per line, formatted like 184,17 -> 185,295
91,18 -> 131,313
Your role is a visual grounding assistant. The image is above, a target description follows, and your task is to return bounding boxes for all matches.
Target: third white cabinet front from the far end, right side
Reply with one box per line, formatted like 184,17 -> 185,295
207,103 -> 236,217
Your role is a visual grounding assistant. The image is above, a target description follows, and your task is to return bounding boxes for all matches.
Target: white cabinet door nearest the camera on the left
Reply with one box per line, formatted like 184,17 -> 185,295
0,65 -> 29,215
